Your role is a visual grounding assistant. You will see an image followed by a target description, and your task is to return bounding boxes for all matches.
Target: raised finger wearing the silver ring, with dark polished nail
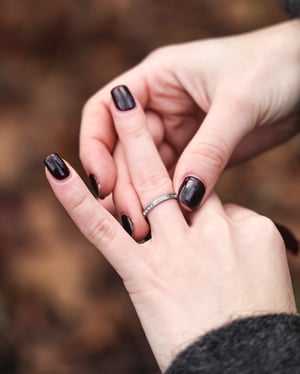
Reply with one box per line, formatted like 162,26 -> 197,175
111,86 -> 185,233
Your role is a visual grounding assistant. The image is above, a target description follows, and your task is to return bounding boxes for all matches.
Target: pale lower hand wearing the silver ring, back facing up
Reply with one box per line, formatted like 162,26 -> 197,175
46,89 -> 296,370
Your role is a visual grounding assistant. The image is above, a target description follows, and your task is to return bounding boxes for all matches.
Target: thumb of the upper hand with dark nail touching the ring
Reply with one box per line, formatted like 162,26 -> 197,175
173,99 -> 254,210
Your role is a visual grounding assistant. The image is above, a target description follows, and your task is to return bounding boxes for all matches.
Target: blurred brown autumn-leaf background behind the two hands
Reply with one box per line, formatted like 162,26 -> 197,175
0,0 -> 300,374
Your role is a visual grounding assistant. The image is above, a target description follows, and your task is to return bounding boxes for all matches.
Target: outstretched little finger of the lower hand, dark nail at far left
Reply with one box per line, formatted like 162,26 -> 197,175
45,154 -> 141,279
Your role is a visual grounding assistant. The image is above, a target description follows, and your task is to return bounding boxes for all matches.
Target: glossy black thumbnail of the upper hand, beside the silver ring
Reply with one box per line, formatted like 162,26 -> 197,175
178,177 -> 205,210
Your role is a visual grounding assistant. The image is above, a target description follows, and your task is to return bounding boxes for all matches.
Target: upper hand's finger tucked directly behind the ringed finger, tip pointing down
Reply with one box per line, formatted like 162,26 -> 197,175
113,143 -> 150,241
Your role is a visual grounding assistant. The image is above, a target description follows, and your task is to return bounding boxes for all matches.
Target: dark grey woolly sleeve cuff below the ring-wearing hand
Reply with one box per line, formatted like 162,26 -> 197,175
165,314 -> 300,374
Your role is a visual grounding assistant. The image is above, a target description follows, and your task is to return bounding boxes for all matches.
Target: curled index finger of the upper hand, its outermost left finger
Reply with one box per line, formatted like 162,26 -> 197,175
79,66 -> 148,197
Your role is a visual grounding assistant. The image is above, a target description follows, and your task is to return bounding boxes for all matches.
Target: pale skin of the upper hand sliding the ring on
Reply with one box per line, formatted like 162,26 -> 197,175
80,20 -> 300,240
